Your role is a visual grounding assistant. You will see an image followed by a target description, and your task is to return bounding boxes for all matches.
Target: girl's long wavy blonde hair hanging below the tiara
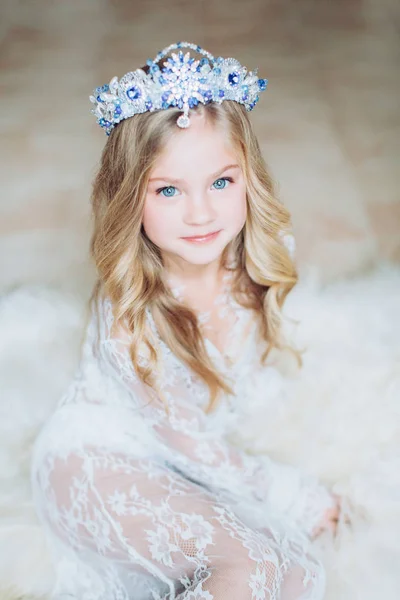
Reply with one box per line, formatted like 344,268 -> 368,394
91,101 -> 297,410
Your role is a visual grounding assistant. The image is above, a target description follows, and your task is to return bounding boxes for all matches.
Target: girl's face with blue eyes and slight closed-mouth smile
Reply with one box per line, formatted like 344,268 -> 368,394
143,114 -> 247,267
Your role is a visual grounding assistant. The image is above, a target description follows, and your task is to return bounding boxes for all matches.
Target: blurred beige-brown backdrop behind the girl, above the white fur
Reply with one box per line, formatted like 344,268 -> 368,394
0,0 -> 400,289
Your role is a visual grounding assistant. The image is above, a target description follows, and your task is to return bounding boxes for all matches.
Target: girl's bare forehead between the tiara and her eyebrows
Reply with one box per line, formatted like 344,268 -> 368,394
151,114 -> 238,179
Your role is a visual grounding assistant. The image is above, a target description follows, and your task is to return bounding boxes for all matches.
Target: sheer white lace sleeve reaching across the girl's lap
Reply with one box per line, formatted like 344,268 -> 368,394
95,303 -> 335,535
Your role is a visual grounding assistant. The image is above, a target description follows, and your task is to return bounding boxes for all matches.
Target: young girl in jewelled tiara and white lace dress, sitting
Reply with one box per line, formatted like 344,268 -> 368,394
32,43 -> 338,600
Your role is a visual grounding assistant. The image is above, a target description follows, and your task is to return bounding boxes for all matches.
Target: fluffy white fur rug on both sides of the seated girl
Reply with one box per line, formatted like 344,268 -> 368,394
0,267 -> 400,600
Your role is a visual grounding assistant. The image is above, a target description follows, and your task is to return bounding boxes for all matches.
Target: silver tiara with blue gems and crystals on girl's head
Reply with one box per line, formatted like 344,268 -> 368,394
90,42 -> 268,135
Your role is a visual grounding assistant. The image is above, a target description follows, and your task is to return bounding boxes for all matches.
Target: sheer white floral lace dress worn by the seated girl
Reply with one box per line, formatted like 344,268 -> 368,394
32,274 -> 333,600
